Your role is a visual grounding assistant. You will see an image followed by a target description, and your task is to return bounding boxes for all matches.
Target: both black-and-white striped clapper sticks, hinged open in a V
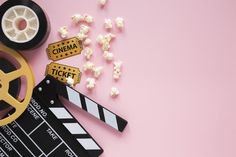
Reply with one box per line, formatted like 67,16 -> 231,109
34,75 -> 128,157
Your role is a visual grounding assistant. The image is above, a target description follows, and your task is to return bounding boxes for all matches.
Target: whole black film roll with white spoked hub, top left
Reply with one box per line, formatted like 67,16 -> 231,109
0,0 -> 50,50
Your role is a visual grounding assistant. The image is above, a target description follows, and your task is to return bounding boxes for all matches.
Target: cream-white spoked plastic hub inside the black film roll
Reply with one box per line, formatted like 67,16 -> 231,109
2,5 -> 39,43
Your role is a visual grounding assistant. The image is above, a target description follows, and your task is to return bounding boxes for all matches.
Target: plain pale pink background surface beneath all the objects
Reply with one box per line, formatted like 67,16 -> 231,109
0,0 -> 236,157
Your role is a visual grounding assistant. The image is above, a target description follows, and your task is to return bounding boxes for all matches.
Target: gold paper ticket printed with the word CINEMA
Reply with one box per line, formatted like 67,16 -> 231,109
47,37 -> 83,61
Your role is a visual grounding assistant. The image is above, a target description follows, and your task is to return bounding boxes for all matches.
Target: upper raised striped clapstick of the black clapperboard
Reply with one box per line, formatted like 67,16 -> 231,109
35,76 -> 128,132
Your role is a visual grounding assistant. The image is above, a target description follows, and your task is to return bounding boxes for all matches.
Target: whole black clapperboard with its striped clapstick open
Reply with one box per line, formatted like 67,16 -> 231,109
0,76 -> 127,157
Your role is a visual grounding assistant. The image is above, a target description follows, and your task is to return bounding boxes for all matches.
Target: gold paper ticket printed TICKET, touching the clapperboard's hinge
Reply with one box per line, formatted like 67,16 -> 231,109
46,62 -> 81,85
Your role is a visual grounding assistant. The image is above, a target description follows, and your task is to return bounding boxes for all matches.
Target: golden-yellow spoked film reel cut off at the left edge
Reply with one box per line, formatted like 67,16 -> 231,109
0,44 -> 34,126
